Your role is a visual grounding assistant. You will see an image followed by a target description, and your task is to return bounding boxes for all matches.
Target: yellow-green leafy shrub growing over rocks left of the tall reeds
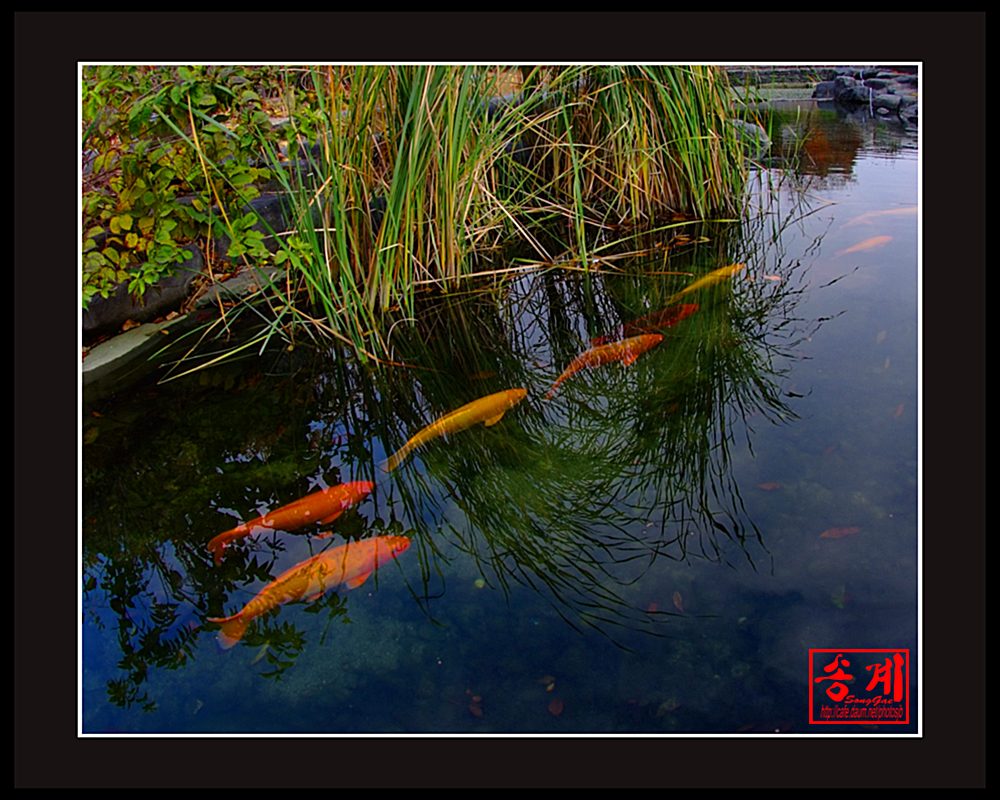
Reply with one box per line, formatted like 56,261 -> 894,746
82,66 -> 277,307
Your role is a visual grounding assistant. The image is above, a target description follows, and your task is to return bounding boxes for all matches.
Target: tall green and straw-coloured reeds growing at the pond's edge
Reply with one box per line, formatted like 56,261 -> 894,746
195,65 -> 745,358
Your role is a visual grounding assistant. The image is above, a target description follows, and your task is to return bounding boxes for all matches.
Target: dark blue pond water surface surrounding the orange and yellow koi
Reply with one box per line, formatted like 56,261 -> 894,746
80,102 -> 919,734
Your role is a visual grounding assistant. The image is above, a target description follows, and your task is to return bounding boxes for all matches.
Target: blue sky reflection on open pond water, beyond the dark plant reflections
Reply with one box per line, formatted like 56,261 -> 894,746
84,114 -> 917,732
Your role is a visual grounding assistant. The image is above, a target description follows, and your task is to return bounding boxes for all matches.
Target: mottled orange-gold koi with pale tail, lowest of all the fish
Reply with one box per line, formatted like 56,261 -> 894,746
208,536 -> 410,650
